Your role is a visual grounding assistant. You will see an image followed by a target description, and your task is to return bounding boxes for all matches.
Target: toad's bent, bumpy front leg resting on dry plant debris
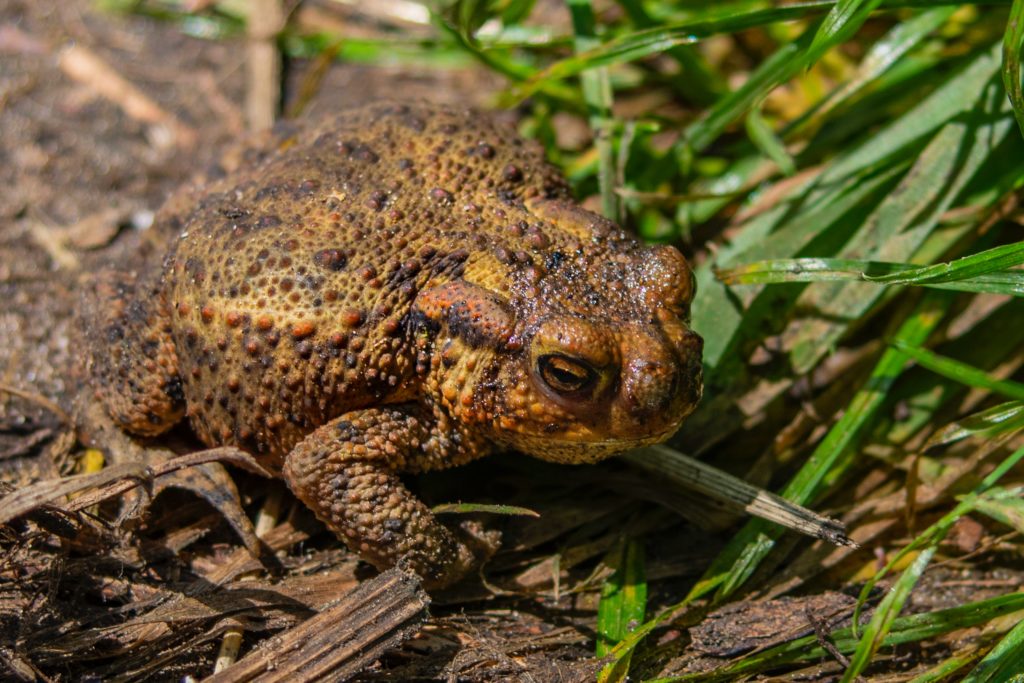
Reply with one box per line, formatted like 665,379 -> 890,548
285,407 -> 498,588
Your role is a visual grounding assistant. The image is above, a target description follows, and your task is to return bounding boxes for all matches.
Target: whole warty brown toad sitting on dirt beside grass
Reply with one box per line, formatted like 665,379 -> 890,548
93,104 -> 700,585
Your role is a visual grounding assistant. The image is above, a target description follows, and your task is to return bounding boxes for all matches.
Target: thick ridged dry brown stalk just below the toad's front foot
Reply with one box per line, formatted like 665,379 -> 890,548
206,569 -> 430,683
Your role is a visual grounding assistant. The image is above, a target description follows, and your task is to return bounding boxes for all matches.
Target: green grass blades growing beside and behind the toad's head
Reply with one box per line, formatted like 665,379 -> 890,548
113,0 -> 1024,681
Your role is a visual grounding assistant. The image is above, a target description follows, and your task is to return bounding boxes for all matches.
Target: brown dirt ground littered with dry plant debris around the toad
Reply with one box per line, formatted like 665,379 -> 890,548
0,0 -> 1020,681
